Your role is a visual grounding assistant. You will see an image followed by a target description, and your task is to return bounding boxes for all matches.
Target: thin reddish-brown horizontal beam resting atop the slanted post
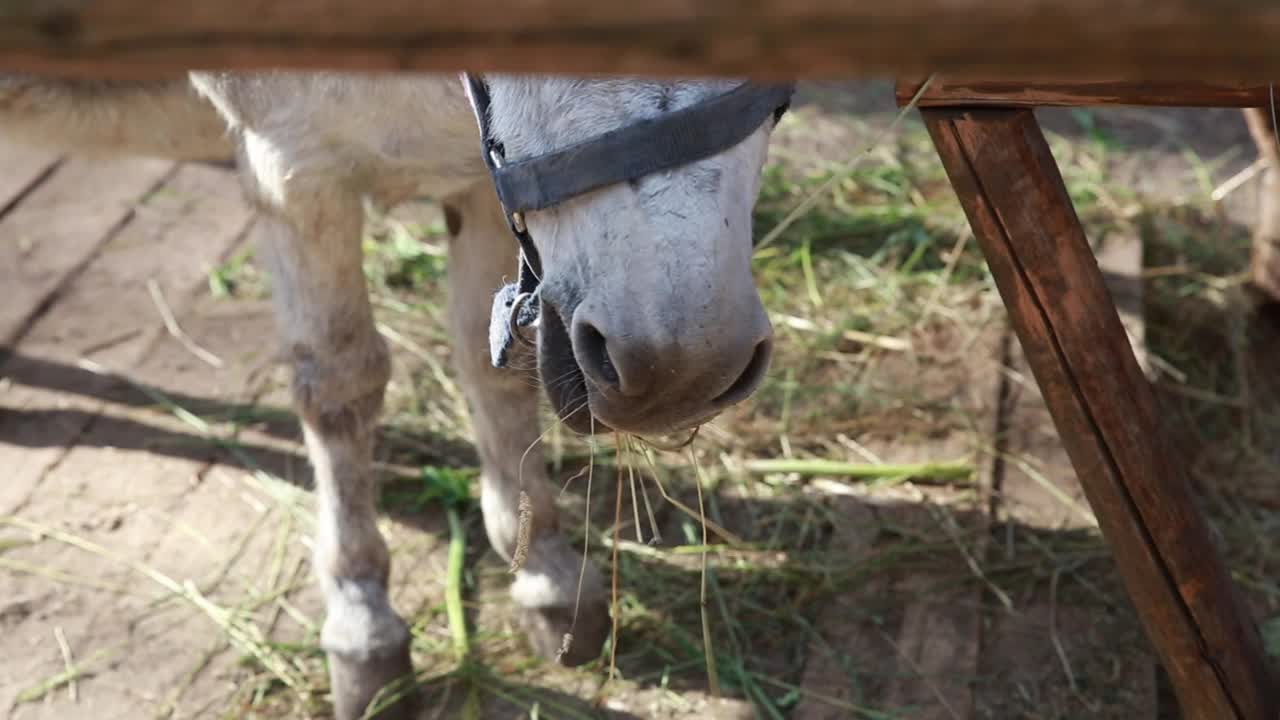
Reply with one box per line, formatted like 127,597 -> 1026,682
896,74 -> 1271,108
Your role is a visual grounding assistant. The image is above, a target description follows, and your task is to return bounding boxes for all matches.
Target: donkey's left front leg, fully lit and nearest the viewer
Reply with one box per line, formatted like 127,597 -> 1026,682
250,170 -> 412,720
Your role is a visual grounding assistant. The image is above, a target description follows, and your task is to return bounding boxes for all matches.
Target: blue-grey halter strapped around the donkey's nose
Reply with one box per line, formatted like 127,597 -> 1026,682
462,73 -> 795,368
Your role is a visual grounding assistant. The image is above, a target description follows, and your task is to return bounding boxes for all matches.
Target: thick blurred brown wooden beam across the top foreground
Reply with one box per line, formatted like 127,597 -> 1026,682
0,0 -> 1280,81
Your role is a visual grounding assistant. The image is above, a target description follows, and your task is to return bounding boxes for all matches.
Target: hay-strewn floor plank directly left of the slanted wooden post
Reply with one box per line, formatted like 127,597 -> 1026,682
974,335 -> 1157,720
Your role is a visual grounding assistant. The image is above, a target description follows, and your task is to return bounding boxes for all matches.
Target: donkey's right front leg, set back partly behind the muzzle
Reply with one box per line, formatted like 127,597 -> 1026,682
445,182 -> 609,665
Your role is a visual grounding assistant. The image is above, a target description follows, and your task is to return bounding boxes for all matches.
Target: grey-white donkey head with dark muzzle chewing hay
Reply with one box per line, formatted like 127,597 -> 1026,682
486,76 -> 773,434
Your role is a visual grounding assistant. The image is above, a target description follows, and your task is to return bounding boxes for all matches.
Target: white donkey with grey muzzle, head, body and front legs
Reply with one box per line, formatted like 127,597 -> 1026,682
0,73 -> 769,720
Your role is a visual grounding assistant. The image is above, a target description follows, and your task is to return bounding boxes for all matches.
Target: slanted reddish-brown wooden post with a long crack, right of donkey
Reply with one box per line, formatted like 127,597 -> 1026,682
924,109 -> 1280,720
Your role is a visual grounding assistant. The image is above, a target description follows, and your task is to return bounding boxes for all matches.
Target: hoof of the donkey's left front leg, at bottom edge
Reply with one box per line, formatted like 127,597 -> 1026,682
329,642 -> 417,720
